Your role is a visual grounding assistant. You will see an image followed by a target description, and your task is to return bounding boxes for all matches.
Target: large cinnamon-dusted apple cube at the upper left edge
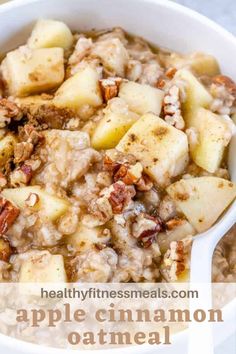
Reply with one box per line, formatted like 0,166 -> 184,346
2,47 -> 64,97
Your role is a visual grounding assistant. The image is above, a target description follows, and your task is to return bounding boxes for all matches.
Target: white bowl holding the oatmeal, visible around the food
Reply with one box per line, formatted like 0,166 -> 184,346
0,0 -> 236,354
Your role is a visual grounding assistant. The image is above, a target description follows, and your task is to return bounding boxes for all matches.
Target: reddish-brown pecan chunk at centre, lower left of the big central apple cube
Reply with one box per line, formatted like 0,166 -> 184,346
108,182 -> 135,214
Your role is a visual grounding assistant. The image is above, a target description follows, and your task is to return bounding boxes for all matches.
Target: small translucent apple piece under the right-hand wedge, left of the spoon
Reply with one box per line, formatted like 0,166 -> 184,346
157,220 -> 196,253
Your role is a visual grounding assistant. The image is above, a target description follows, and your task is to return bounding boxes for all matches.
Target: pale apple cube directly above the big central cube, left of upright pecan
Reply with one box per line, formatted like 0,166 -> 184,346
119,81 -> 164,115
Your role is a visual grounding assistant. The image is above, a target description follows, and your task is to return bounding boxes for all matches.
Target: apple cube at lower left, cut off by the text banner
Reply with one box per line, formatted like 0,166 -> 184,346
19,251 -> 67,283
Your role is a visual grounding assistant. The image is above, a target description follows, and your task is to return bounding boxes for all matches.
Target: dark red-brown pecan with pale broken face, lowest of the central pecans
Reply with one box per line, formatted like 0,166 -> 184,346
132,213 -> 162,248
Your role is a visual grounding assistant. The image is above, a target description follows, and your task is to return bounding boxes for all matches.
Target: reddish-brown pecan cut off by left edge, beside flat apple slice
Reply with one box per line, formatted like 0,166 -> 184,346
0,197 -> 20,235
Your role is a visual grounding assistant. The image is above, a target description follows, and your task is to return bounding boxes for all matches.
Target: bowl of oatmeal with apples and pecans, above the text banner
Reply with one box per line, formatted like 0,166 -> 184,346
0,0 -> 236,352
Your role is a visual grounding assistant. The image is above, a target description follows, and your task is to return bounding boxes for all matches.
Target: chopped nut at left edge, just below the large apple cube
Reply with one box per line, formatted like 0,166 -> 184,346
0,98 -> 23,128
